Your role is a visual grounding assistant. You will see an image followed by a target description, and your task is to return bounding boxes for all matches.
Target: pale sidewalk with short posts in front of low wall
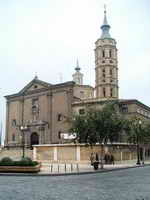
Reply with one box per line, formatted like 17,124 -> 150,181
38,160 -> 150,176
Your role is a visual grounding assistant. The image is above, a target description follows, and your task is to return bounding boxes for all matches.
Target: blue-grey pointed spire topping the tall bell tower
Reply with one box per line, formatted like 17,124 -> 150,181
101,5 -> 111,39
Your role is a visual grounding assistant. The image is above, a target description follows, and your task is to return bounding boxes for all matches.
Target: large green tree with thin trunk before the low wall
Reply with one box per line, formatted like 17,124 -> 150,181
71,102 -> 124,168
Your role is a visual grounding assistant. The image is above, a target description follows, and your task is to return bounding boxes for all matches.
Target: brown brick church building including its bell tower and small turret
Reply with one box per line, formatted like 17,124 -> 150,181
5,10 -> 150,146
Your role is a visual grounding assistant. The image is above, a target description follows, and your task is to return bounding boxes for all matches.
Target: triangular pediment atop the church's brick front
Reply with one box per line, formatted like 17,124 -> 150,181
19,79 -> 51,94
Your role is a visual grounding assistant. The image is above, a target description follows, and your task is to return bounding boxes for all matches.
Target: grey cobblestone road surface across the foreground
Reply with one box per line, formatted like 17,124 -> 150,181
0,166 -> 150,200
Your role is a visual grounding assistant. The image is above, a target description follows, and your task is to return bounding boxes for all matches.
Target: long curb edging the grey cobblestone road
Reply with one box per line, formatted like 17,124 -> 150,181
0,164 -> 150,177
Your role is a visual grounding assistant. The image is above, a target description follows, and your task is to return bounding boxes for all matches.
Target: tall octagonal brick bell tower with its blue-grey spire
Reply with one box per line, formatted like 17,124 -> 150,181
95,7 -> 118,100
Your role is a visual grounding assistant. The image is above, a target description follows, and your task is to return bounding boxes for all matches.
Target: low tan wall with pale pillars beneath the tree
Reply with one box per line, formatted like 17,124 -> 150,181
33,144 -> 136,162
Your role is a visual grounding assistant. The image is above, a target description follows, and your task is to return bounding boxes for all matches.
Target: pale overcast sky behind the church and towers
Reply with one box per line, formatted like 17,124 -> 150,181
0,0 -> 150,134
